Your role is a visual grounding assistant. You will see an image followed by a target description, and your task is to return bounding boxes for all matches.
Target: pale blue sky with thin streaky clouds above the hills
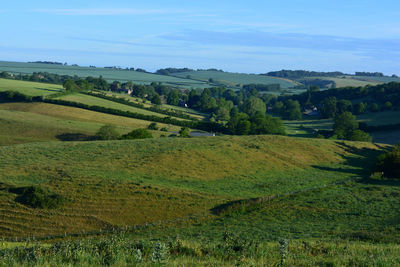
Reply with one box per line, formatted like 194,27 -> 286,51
0,0 -> 400,75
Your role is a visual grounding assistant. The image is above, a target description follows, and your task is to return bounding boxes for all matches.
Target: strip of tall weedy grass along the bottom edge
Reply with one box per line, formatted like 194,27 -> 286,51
0,235 -> 400,266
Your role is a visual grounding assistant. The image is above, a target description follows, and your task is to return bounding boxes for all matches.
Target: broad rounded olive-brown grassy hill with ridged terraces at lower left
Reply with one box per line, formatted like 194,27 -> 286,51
0,136 -> 380,239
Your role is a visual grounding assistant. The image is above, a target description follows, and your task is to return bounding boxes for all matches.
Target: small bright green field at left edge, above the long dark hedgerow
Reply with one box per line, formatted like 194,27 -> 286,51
0,79 -> 64,96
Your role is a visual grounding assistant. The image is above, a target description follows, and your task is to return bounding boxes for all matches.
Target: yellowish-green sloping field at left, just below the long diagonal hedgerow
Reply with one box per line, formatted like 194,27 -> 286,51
0,103 -> 180,145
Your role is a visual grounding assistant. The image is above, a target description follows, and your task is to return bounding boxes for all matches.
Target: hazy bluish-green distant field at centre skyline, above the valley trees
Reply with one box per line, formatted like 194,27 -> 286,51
171,71 -> 296,88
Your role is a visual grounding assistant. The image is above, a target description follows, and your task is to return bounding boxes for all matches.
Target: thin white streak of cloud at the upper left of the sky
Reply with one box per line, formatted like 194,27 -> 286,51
33,8 -> 185,16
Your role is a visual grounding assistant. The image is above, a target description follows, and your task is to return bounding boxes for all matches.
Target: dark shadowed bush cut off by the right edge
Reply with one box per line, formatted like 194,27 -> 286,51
378,144 -> 400,178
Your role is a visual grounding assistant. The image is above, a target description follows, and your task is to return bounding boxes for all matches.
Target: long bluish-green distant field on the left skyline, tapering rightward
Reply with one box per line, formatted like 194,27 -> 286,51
0,61 -> 208,88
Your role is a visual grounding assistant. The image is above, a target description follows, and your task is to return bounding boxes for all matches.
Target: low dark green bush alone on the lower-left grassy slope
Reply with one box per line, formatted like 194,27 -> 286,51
11,186 -> 64,209
